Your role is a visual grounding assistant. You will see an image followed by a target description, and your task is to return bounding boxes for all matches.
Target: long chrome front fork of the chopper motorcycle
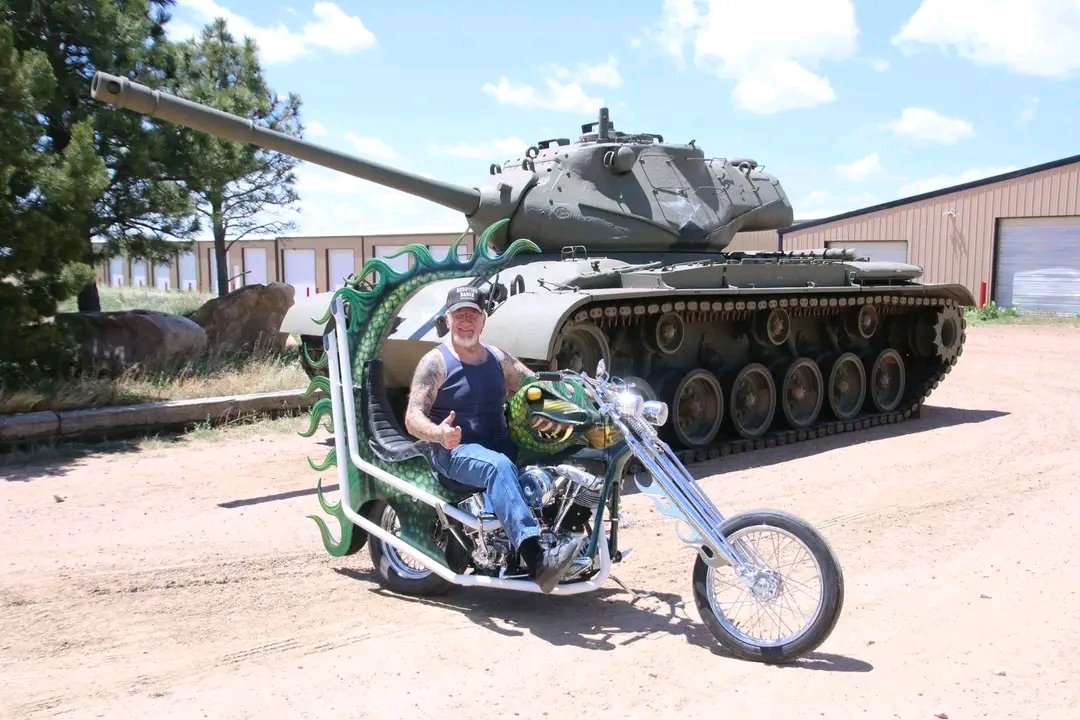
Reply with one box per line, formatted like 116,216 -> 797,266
579,375 -> 754,569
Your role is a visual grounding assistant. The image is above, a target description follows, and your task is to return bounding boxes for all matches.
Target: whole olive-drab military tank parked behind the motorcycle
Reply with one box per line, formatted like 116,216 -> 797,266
91,72 -> 973,461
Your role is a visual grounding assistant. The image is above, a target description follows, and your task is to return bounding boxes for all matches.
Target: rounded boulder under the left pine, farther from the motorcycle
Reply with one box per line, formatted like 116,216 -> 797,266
56,310 -> 206,375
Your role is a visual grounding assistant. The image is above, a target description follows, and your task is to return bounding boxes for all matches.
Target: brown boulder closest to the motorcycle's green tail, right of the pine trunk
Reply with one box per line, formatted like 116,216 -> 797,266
191,283 -> 295,352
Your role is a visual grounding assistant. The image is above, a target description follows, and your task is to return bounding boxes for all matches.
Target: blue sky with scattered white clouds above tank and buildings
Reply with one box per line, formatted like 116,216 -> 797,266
167,0 -> 1080,234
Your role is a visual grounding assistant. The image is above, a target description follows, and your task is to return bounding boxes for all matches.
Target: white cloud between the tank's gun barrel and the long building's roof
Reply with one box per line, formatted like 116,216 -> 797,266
289,163 -> 468,235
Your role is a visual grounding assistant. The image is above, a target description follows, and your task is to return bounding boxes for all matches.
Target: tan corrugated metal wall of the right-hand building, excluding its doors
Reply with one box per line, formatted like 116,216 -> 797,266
783,163 -> 1080,298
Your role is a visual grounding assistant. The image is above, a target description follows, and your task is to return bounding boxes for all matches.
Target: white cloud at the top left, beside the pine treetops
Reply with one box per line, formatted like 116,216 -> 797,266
173,0 -> 375,65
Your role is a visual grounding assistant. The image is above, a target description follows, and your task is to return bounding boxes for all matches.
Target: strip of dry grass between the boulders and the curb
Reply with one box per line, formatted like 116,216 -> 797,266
0,351 -> 308,413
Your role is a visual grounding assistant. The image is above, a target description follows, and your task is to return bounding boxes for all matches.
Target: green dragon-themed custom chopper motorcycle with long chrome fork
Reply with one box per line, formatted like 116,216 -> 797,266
301,220 -> 843,663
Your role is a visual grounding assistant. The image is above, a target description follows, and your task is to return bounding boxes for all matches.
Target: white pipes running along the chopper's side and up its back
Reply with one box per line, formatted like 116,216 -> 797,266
325,297 -> 611,595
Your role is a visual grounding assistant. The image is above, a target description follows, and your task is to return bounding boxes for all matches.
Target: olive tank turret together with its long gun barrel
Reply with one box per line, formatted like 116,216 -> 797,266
91,72 -> 793,253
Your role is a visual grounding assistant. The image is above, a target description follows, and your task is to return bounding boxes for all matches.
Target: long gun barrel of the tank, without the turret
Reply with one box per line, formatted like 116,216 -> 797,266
90,71 -> 481,217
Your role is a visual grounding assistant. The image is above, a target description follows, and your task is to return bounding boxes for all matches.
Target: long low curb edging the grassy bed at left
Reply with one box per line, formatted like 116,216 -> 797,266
0,390 -> 316,446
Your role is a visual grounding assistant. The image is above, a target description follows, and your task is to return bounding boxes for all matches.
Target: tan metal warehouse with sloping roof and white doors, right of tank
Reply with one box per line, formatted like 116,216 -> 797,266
780,155 -> 1080,314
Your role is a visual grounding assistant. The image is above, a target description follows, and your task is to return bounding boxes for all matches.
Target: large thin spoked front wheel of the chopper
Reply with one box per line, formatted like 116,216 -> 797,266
693,511 -> 843,664
